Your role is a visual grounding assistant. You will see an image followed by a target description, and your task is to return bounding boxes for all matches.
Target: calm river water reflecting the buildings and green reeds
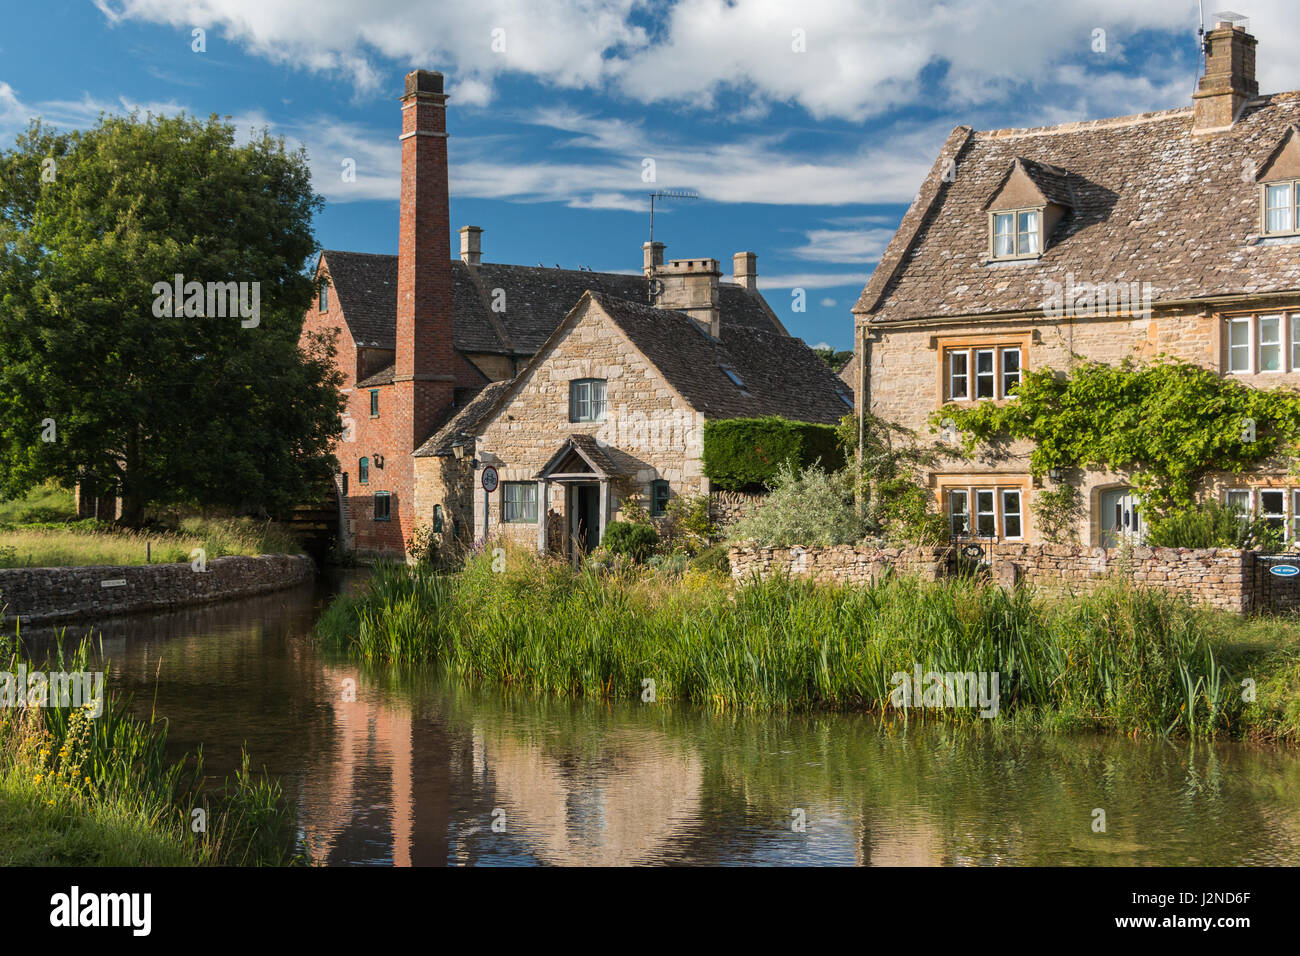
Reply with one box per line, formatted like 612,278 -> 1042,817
25,579 -> 1300,866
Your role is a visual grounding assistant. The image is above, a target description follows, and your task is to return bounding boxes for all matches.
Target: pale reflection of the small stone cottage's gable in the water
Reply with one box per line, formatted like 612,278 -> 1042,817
476,730 -> 703,866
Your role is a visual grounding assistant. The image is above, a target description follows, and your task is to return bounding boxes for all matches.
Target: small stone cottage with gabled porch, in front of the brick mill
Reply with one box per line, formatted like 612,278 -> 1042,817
416,290 -> 853,555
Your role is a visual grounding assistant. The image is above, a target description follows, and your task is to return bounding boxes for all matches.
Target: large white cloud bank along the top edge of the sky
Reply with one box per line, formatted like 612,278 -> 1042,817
78,0 -> 1300,121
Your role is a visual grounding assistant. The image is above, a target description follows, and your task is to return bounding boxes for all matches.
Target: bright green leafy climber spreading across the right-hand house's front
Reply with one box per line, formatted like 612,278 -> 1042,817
931,356 -> 1300,519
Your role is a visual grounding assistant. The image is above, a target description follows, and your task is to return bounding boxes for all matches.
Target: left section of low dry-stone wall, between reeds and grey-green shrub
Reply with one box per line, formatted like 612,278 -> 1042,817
729,545 -> 953,584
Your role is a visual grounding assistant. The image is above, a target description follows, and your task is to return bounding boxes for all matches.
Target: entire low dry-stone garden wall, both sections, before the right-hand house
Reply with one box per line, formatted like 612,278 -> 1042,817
731,542 -> 1300,614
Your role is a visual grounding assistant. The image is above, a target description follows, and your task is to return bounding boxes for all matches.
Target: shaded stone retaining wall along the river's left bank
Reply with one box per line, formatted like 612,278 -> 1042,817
0,554 -> 316,627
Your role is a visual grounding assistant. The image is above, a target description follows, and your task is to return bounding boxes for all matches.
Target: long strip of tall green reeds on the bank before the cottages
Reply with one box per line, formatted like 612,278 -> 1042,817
317,551 -> 1300,740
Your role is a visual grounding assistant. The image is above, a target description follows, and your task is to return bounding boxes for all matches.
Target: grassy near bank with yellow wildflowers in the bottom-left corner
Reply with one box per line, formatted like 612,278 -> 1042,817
0,634 -> 294,866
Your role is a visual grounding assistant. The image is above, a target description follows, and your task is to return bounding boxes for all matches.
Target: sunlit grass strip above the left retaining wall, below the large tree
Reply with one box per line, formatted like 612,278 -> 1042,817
0,518 -> 302,567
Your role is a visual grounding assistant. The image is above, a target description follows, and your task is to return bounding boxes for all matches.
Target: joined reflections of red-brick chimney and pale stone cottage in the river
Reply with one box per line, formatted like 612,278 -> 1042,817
298,667 -> 703,866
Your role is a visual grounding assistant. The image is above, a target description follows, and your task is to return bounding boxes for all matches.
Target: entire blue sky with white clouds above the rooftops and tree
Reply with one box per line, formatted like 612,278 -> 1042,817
0,0 -> 1300,349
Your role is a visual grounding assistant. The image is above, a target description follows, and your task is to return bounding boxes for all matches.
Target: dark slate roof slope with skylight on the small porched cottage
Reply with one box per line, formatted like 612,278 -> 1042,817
592,293 -> 852,424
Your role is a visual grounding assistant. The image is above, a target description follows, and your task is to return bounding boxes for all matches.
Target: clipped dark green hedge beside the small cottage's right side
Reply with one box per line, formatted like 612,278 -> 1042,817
703,415 -> 844,492
